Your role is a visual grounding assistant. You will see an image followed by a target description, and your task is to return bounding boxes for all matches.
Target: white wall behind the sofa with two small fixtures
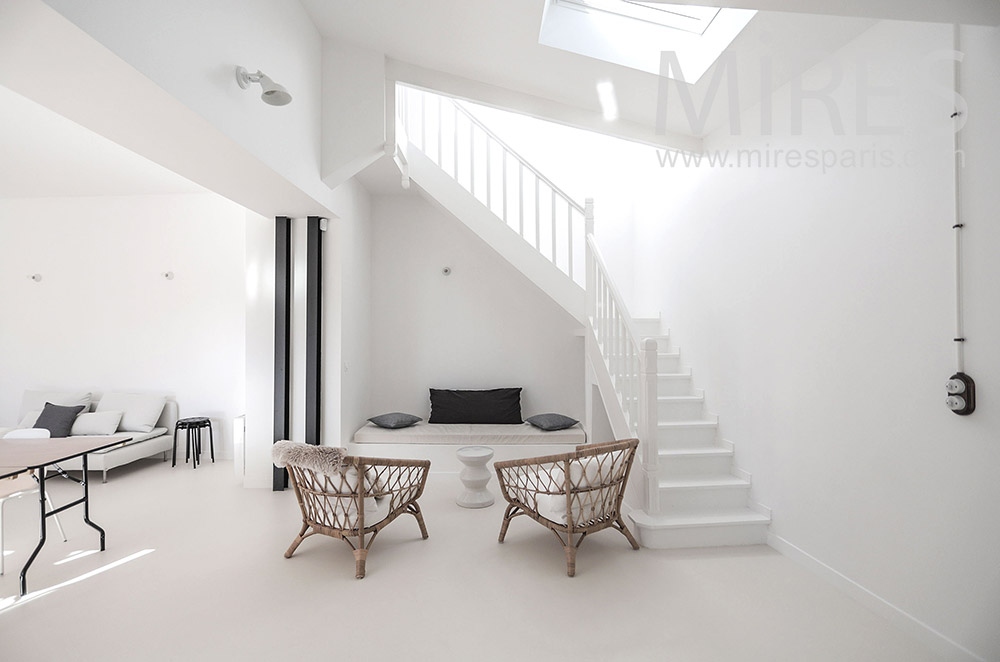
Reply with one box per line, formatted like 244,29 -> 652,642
0,194 -> 245,457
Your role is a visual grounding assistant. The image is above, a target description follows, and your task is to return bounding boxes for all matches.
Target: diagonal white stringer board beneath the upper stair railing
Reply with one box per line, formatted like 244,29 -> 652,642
406,144 -> 585,324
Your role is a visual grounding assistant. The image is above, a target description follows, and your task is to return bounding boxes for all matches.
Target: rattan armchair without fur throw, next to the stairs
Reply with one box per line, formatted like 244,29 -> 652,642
493,439 -> 639,577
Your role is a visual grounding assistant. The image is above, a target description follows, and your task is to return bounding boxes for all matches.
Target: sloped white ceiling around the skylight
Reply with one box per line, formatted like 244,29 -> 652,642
300,0 -> 874,135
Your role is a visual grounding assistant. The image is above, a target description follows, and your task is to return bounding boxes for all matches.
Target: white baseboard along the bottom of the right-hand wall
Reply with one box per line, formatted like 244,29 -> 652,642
767,533 -> 986,662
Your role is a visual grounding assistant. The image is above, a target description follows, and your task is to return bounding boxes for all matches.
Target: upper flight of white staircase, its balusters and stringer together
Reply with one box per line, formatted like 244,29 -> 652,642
396,86 -> 593,324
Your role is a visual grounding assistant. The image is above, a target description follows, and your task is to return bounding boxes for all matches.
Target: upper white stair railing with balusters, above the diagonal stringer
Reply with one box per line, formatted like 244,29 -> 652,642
396,85 -> 588,287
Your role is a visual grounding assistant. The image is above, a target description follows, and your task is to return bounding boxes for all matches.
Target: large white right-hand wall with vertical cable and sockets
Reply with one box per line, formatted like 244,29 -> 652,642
636,23 -> 1000,660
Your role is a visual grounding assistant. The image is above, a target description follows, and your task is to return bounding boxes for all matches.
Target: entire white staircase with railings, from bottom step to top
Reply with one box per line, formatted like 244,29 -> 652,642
396,86 -> 770,548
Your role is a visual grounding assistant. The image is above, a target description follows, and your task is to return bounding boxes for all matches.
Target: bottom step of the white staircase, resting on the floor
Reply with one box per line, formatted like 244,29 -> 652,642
628,508 -> 771,549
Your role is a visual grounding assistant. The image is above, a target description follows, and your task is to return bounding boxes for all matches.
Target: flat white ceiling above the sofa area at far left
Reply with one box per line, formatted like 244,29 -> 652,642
0,86 -> 205,198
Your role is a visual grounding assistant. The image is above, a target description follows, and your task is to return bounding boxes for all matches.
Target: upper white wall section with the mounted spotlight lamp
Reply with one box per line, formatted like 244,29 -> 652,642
46,0 -> 330,211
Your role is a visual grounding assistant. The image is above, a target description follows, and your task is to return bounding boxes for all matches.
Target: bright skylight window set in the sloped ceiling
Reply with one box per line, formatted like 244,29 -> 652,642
538,0 -> 757,84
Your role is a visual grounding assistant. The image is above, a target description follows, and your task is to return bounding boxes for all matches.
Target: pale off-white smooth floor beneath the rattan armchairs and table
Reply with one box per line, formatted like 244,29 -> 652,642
0,461 -> 938,662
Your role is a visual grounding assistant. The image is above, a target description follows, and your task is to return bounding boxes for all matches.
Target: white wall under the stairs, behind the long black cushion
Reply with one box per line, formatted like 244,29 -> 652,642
366,195 -> 584,420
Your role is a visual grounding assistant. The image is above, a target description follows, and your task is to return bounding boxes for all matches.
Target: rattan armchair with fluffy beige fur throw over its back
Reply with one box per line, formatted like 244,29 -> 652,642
273,441 -> 431,579
